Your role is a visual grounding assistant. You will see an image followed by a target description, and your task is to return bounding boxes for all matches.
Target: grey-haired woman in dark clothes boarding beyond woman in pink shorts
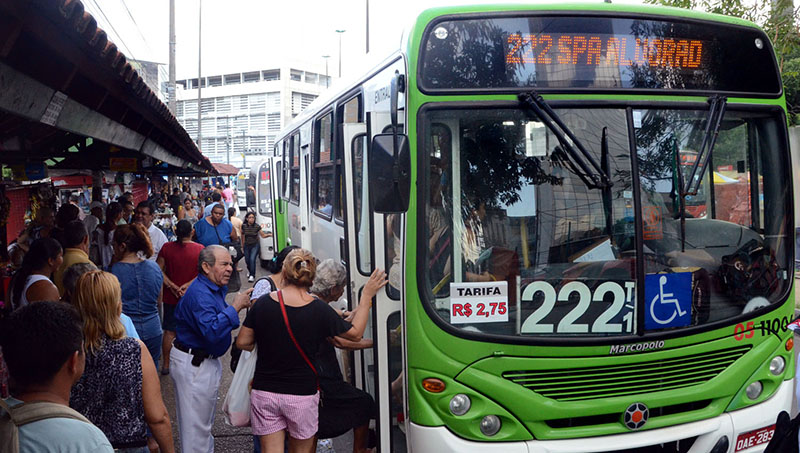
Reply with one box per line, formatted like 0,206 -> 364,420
310,259 -> 386,453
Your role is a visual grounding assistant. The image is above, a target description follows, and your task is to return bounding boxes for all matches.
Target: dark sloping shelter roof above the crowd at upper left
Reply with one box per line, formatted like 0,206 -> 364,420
0,0 -> 214,173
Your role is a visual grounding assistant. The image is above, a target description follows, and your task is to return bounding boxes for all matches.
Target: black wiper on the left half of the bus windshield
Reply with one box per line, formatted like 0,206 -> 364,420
517,91 -> 613,189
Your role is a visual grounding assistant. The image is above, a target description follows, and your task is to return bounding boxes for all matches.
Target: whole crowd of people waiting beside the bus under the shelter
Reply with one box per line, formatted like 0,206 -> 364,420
0,183 -> 387,453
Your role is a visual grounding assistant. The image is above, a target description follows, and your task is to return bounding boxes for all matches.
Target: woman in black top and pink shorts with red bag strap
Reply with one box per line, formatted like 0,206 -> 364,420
236,249 -> 382,453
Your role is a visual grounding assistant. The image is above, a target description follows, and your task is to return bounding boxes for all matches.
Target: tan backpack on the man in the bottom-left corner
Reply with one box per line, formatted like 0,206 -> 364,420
0,399 -> 92,453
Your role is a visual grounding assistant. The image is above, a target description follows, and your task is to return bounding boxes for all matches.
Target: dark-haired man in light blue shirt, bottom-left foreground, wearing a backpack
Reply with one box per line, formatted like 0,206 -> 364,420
0,302 -> 114,453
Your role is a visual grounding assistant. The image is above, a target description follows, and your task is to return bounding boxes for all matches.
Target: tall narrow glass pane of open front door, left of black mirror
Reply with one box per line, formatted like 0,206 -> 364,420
353,135 -> 372,275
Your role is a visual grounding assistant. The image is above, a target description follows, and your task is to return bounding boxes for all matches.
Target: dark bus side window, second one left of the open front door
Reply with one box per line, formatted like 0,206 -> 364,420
311,113 -> 337,218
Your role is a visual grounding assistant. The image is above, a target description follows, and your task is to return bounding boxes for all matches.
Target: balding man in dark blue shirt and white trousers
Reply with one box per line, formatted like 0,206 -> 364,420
170,245 -> 253,453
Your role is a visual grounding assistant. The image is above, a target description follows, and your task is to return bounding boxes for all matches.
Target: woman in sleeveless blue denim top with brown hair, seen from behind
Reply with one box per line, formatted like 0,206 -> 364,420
111,223 -> 164,368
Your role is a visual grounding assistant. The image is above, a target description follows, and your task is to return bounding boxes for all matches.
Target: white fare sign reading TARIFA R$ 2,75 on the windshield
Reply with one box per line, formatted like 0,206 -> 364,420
450,281 -> 508,324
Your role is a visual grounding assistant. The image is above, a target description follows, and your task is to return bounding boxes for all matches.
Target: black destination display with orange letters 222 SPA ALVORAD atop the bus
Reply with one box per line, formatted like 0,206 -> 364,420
419,15 -> 782,97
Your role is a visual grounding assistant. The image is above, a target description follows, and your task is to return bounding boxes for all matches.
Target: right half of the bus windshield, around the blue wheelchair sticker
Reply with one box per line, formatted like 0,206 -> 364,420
634,109 -> 791,330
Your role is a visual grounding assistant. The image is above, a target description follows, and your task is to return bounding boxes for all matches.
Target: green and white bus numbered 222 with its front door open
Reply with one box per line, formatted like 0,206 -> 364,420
276,3 -> 794,453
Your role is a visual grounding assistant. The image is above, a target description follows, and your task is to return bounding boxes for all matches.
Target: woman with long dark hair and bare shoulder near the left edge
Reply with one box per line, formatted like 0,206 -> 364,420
8,238 -> 64,309
